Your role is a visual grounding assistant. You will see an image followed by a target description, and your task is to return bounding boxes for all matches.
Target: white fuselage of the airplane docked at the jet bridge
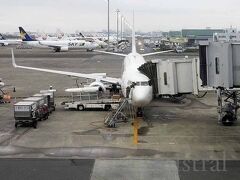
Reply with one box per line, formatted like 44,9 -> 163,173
121,53 -> 153,107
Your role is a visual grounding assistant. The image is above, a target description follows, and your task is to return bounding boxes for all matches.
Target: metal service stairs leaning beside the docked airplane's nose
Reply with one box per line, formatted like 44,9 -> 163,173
104,99 -> 132,127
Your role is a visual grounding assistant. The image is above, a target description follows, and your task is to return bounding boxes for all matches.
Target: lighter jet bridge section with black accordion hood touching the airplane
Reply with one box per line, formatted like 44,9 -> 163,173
139,58 -> 198,96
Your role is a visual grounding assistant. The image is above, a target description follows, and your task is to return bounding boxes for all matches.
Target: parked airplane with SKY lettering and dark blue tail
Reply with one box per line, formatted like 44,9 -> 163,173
19,27 -> 98,52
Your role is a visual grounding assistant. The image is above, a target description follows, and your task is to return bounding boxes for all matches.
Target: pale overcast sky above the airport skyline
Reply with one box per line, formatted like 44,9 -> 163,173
0,0 -> 240,32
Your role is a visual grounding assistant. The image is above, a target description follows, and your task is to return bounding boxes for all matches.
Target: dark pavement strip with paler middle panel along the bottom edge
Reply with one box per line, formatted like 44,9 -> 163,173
0,158 -> 240,180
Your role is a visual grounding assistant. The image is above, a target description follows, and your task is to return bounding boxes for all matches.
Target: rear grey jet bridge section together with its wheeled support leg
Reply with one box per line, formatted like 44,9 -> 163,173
199,41 -> 240,125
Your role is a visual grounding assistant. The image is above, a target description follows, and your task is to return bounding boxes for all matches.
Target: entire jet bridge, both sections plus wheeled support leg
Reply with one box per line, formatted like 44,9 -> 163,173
139,49 -> 240,125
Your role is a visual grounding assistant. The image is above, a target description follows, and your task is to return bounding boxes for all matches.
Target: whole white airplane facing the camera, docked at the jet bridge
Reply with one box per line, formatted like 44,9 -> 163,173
11,17 -> 173,113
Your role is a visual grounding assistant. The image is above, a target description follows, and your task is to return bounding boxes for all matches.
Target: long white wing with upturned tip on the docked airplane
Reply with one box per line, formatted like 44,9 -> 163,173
11,49 -> 121,84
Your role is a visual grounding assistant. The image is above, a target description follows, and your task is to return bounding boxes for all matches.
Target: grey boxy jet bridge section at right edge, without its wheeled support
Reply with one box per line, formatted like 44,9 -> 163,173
199,41 -> 240,88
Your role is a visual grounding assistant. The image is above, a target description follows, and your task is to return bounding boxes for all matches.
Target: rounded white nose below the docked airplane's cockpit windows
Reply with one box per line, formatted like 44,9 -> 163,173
132,86 -> 153,107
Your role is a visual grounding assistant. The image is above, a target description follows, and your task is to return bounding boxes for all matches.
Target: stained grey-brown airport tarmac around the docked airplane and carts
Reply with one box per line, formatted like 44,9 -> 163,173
0,47 -> 240,179
